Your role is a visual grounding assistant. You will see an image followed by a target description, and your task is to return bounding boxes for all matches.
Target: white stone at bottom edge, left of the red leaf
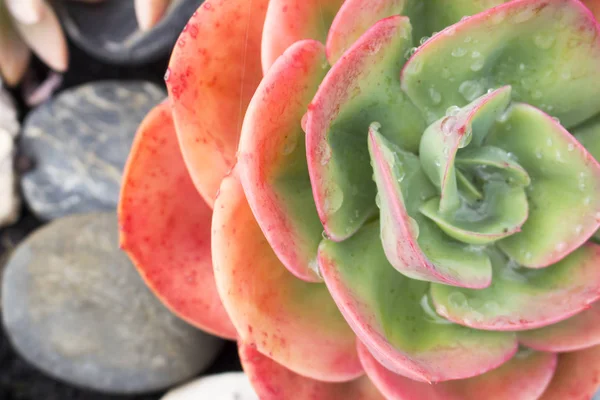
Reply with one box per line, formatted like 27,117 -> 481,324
161,372 -> 258,400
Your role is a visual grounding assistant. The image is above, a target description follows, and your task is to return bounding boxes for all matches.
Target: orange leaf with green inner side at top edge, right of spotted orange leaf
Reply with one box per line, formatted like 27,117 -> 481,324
262,0 -> 343,75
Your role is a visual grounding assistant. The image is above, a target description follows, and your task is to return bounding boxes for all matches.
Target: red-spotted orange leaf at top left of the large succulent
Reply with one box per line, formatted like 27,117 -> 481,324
165,0 -> 268,207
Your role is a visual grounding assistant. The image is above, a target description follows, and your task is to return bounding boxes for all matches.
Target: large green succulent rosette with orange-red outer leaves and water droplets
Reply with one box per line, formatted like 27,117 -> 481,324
119,0 -> 600,400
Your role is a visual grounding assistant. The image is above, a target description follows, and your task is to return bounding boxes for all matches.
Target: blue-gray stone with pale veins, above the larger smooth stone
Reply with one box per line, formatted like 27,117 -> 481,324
20,81 -> 165,219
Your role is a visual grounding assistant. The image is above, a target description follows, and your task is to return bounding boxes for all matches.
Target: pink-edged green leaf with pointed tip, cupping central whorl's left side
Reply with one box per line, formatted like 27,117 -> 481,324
369,124 -> 492,288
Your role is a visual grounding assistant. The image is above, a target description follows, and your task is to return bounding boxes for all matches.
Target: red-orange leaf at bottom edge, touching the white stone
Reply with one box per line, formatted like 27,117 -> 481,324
238,342 -> 383,400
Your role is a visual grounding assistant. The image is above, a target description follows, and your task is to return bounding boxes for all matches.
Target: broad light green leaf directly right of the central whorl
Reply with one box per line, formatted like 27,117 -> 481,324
485,104 -> 600,268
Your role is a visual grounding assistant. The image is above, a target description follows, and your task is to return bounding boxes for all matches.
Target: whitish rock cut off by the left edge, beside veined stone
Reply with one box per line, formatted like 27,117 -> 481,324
0,85 -> 21,227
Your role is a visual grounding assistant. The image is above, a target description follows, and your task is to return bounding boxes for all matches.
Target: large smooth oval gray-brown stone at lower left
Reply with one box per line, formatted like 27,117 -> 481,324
2,213 -> 223,393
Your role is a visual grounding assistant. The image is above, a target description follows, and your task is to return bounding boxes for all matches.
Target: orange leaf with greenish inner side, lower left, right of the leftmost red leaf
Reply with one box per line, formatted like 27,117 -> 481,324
212,170 -> 363,382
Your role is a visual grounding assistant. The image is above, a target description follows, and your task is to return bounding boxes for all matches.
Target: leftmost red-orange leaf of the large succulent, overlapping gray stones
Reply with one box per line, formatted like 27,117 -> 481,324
119,103 -> 236,339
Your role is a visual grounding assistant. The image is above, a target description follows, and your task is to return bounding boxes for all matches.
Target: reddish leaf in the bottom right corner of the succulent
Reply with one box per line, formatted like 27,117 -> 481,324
540,346 -> 600,400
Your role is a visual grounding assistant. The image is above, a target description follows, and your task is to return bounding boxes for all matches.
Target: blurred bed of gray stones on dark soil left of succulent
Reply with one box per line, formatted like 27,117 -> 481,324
0,0 -> 246,400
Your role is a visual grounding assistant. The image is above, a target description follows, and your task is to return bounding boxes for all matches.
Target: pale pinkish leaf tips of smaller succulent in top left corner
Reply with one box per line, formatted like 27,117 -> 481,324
0,0 -> 171,86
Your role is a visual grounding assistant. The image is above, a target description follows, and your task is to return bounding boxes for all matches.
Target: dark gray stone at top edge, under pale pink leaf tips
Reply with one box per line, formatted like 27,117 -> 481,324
56,0 -> 202,65
